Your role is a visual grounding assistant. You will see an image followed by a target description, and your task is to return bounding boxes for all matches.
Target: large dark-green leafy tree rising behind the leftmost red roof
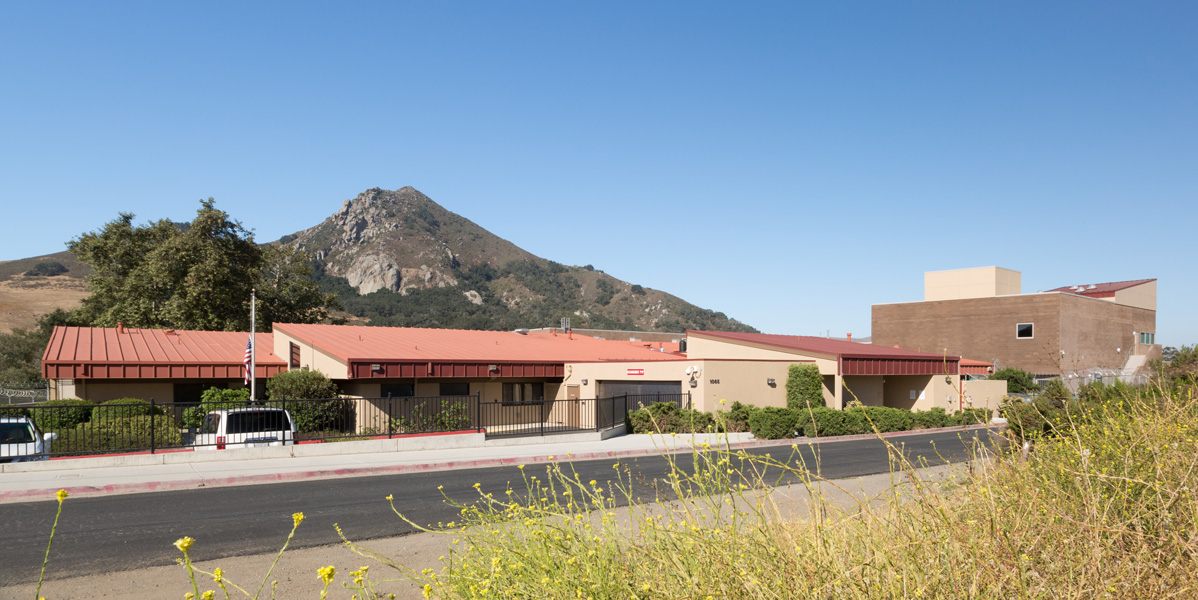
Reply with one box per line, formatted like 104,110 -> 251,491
67,198 -> 332,331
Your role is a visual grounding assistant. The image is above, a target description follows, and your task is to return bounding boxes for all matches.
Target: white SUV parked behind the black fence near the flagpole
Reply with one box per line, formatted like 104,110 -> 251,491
195,407 -> 296,450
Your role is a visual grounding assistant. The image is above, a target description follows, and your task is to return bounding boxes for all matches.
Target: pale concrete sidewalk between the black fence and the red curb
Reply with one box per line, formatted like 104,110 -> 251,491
0,425 -> 981,503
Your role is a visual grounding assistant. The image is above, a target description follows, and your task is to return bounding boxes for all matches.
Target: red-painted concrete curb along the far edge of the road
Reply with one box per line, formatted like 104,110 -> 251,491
0,425 -> 1001,503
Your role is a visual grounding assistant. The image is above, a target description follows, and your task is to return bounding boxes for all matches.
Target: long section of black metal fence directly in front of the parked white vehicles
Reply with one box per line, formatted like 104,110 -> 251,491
0,395 -> 479,461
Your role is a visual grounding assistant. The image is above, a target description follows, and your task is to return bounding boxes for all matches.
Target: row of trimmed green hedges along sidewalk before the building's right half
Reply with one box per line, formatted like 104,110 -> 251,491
628,402 -> 991,440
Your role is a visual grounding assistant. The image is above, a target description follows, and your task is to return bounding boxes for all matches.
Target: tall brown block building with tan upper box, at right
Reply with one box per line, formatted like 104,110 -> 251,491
872,267 -> 1160,378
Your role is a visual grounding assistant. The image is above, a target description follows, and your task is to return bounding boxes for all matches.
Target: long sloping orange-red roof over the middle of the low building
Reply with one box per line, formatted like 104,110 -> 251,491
274,323 -> 683,364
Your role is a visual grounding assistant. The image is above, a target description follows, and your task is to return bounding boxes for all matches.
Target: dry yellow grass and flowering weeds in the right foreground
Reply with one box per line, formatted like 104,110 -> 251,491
359,383 -> 1198,599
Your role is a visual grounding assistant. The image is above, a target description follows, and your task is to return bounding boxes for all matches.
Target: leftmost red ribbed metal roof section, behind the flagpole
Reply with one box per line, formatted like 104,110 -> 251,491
42,327 -> 286,378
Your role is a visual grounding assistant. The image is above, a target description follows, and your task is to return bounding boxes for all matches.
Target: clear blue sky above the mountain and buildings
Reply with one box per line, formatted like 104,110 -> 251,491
0,2 -> 1198,345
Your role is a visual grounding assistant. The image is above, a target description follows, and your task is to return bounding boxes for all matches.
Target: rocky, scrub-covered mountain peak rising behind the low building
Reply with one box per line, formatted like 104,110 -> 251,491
287,187 -> 755,332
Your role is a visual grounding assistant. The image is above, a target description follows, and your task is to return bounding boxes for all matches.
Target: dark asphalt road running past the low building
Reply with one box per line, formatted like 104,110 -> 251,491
0,430 -> 987,586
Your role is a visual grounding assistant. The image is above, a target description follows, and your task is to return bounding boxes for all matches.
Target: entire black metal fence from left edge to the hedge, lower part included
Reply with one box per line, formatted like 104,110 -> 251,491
0,394 -> 690,461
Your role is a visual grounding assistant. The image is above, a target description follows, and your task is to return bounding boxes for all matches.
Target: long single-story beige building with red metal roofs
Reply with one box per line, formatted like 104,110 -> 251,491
43,323 -> 1005,416
